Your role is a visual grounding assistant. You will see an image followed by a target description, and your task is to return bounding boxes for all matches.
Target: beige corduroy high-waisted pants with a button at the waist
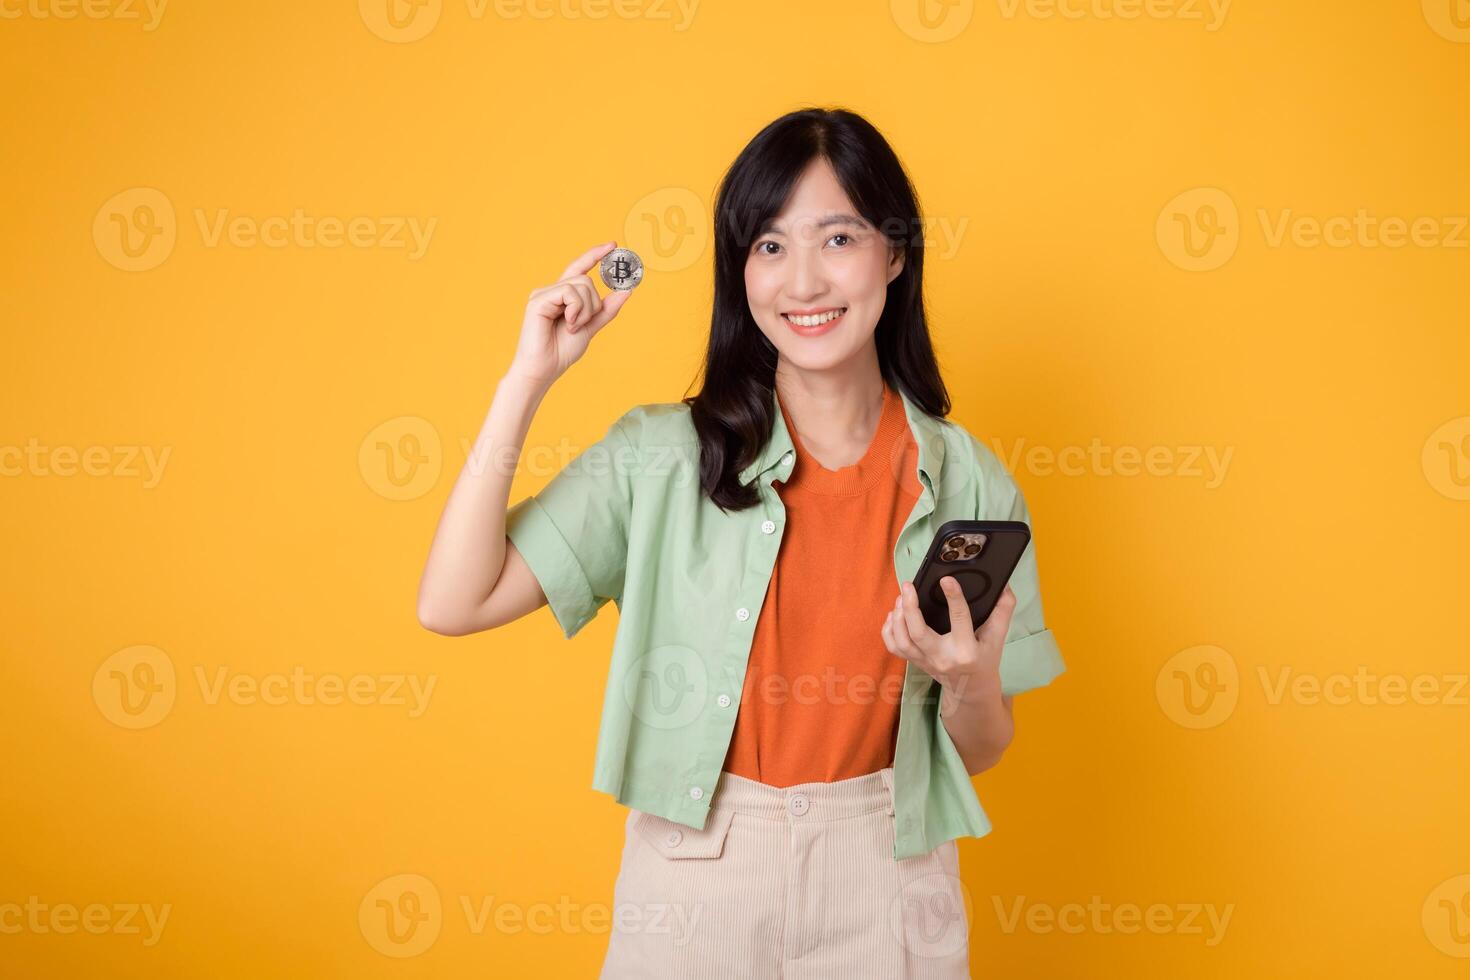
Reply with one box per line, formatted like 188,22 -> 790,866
590,767 -> 970,980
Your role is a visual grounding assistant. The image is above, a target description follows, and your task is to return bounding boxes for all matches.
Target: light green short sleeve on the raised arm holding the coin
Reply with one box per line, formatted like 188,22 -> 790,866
506,416 -> 637,639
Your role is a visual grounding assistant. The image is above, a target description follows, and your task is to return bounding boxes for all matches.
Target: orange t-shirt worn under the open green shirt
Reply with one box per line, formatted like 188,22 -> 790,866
725,383 -> 920,786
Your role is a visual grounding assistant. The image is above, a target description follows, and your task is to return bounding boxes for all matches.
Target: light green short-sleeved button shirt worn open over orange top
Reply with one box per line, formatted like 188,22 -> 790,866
506,382 -> 1064,860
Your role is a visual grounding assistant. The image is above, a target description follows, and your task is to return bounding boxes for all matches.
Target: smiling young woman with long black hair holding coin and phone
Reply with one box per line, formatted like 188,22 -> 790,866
419,109 -> 1063,979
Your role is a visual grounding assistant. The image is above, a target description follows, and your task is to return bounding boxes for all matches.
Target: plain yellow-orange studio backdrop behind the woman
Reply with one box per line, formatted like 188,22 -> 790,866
0,0 -> 1470,979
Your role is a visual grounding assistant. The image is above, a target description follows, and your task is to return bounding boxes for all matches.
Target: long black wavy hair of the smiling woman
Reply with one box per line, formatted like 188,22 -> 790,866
682,107 -> 950,511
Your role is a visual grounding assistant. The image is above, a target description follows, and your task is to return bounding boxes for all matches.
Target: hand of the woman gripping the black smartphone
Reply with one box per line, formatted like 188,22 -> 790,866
882,574 -> 1016,699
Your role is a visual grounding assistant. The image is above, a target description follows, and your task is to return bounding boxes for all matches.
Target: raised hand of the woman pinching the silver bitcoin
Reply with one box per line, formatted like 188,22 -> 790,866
510,241 -> 632,388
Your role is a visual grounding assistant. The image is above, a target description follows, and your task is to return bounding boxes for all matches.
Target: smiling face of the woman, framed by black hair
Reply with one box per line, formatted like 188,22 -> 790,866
745,157 -> 904,370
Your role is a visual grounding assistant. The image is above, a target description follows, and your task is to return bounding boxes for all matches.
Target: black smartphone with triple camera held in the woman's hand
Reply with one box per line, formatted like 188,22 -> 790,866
914,520 -> 1030,633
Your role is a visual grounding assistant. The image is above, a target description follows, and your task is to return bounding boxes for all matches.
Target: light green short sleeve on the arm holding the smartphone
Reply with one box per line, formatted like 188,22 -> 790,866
980,457 -> 1067,695
